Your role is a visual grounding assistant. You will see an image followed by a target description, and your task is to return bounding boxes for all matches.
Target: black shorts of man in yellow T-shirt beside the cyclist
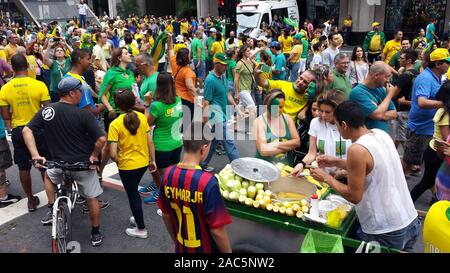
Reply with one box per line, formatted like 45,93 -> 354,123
11,126 -> 51,171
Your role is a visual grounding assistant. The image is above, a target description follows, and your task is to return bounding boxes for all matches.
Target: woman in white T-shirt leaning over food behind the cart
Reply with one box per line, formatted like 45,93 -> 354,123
293,90 -> 352,178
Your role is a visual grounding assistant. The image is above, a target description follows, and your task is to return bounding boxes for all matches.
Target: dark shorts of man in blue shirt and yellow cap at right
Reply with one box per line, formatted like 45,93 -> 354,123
403,128 -> 433,165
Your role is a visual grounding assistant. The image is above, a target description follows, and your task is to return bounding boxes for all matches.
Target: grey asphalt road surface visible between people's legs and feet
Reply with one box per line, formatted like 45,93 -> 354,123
0,120 -> 431,253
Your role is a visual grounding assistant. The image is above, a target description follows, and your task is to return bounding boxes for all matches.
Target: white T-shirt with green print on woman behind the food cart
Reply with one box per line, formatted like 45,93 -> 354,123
308,118 -> 352,173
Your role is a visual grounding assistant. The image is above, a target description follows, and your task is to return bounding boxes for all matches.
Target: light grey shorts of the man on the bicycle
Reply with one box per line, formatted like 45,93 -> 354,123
47,168 -> 103,199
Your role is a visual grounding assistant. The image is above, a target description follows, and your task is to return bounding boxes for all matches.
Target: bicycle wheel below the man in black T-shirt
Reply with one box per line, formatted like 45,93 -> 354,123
52,202 -> 72,253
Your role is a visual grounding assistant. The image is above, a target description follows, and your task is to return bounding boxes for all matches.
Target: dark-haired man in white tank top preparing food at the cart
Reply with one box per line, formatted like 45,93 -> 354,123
312,101 -> 420,251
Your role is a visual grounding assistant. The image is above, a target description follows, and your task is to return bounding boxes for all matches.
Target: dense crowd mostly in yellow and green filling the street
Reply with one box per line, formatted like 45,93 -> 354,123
0,6 -> 450,252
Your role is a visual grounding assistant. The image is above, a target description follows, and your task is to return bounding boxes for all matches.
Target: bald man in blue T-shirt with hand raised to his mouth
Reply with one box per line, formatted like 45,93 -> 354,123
350,62 -> 399,132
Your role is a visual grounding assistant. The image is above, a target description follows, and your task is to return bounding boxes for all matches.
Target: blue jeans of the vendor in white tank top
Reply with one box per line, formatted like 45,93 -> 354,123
356,218 -> 421,252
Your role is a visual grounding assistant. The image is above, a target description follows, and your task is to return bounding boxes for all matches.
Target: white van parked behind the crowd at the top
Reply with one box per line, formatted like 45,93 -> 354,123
236,0 -> 300,35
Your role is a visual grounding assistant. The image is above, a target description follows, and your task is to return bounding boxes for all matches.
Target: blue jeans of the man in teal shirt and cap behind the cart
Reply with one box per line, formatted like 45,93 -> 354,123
201,121 -> 239,165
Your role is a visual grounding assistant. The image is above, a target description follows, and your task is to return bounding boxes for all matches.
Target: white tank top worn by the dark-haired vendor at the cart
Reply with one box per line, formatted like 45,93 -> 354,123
354,129 -> 417,235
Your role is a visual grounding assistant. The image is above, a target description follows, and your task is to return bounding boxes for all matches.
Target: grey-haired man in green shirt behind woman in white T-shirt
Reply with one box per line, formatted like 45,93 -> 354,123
328,53 -> 352,98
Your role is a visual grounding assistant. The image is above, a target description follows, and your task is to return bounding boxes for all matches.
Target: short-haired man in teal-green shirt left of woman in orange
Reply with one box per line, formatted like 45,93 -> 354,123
136,53 -> 159,111
